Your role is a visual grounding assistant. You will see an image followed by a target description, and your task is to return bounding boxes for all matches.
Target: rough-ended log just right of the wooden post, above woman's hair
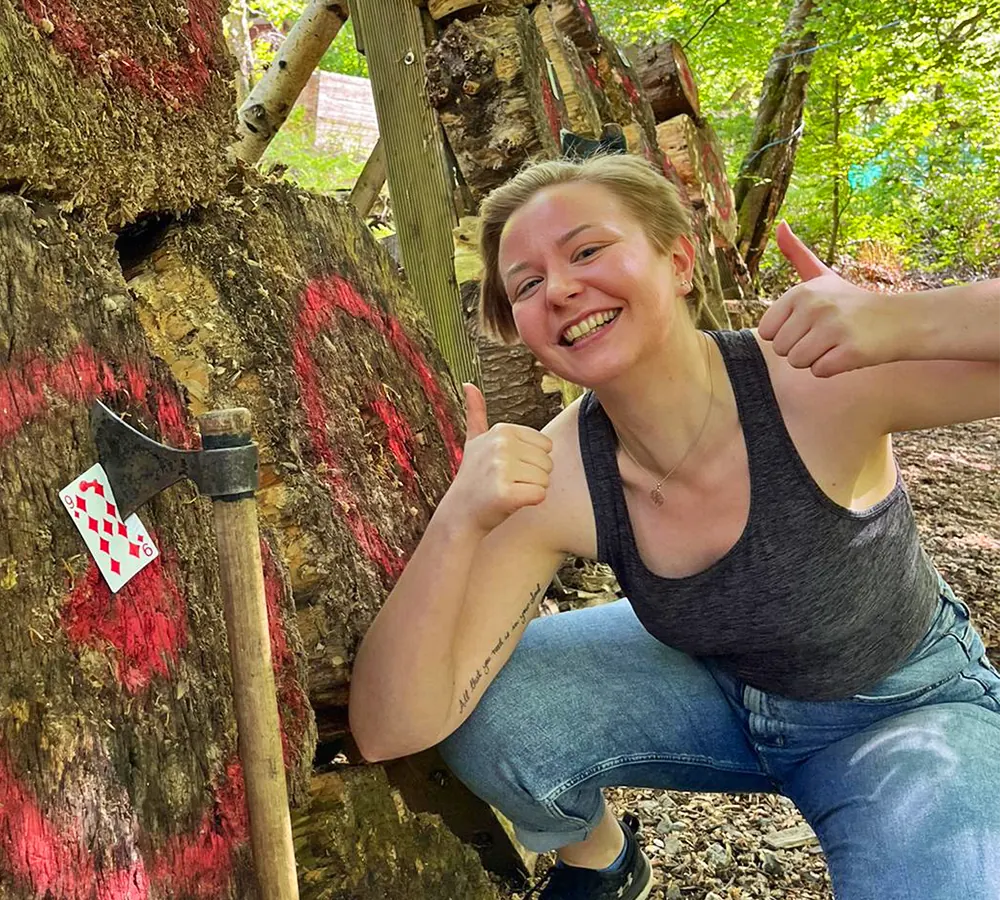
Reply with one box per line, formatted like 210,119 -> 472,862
427,10 -> 568,202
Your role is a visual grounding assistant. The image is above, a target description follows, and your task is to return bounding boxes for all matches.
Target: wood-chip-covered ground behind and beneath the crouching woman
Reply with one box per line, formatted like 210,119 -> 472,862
501,419 -> 1000,900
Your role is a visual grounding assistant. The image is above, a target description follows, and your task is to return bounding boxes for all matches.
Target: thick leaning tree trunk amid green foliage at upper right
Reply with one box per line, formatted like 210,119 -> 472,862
735,0 -> 816,277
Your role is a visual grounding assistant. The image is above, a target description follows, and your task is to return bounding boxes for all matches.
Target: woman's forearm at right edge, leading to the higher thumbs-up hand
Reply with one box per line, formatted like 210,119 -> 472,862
893,278 -> 1000,362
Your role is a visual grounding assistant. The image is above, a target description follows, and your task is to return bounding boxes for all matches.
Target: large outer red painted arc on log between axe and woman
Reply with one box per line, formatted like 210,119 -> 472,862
292,275 -> 461,579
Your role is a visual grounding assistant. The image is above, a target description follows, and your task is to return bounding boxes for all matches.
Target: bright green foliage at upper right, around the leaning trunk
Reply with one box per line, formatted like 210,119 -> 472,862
593,0 -> 1000,267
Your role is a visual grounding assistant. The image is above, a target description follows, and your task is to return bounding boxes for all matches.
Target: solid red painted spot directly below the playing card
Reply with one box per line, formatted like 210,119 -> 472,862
62,556 -> 187,694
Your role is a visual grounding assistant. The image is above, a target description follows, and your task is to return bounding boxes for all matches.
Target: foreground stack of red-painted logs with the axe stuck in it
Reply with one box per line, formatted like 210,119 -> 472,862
0,0 -> 508,900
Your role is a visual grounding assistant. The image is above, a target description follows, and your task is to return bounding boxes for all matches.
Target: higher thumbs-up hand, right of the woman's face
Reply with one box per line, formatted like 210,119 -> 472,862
757,222 -> 898,378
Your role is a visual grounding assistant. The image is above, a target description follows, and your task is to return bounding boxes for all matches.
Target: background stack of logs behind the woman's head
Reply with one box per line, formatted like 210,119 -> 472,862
426,0 -> 728,428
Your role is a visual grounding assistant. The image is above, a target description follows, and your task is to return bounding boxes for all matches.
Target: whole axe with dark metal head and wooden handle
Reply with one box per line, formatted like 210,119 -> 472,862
90,400 -> 299,900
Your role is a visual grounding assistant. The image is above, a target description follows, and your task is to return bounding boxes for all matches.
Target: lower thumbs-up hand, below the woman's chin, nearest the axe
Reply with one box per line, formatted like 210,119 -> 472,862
442,384 -> 552,535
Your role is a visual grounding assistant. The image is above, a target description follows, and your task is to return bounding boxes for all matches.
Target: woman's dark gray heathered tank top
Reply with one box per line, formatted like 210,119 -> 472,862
580,330 -> 940,700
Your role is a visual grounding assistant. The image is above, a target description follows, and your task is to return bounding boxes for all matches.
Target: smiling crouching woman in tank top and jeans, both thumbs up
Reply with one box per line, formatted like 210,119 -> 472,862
350,156 -> 1000,900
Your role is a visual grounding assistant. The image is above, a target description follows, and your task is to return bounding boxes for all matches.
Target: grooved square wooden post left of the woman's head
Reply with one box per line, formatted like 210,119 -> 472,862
351,0 -> 481,384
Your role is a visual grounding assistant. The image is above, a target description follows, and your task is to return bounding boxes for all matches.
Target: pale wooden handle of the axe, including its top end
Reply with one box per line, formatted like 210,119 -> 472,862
199,409 -> 299,900
